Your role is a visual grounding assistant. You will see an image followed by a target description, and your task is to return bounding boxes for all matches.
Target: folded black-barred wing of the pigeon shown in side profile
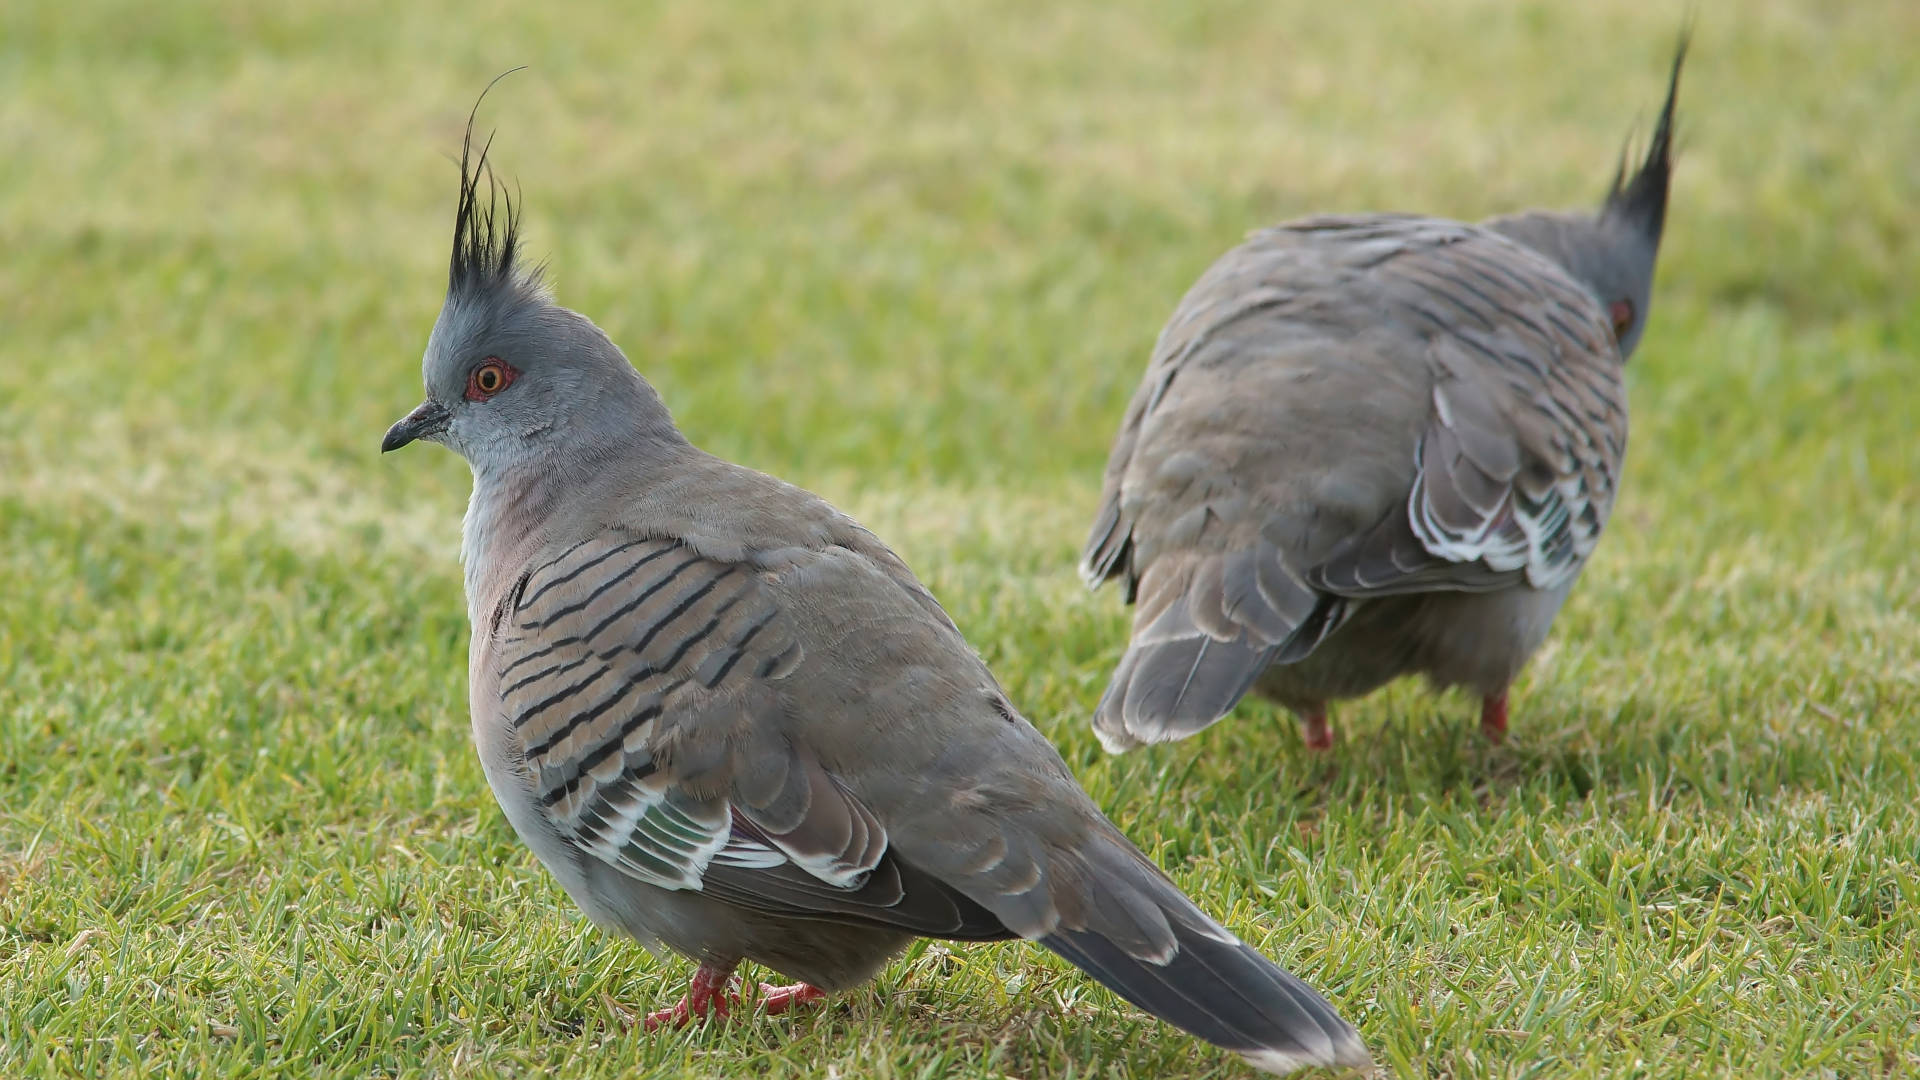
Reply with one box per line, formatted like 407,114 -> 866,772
492,530 -> 1010,938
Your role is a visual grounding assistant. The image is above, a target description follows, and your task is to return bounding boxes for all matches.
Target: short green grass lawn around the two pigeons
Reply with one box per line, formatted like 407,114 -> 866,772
0,0 -> 1920,1078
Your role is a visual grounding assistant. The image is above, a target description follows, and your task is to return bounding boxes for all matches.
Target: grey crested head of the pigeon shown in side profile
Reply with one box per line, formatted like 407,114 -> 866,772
380,94 -> 685,475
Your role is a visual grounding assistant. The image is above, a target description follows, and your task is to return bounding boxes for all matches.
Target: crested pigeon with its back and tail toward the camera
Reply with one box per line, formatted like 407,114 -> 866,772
1081,40 -> 1686,751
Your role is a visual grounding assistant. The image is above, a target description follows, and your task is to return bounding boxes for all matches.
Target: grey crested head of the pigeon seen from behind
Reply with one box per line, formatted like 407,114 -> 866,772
1486,37 -> 1688,359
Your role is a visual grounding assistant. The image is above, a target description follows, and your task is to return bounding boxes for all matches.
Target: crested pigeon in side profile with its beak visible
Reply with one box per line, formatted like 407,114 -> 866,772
380,100 -> 1369,1072
